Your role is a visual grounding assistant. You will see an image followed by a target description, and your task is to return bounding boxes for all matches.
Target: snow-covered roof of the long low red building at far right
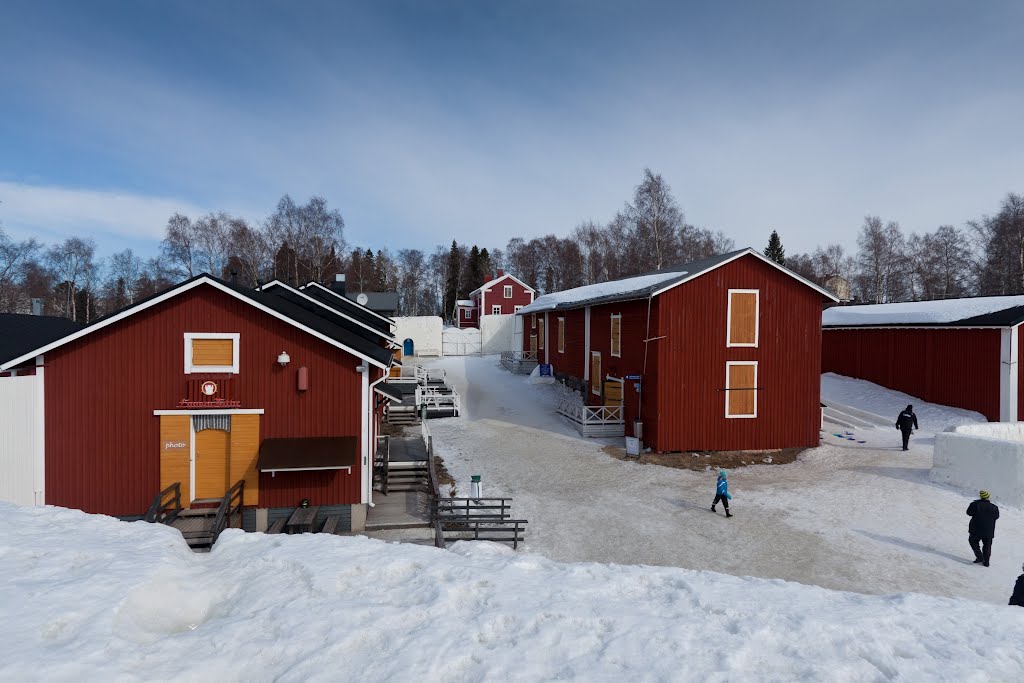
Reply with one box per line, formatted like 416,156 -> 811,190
821,296 -> 1024,328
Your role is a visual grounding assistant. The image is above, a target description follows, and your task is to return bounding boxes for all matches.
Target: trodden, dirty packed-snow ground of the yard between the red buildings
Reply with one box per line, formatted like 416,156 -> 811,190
426,356 -> 1024,605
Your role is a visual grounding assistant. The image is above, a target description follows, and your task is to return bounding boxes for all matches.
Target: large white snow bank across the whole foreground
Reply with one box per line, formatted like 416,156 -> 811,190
6,505 -> 1024,681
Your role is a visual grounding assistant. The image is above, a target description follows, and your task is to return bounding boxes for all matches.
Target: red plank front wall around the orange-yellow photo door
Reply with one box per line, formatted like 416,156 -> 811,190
45,286 -> 361,515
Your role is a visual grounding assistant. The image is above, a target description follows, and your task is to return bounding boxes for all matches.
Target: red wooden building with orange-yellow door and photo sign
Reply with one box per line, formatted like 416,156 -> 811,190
0,274 -> 394,529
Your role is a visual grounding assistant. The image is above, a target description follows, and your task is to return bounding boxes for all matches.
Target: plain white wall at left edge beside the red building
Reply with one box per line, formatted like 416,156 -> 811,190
0,375 -> 43,505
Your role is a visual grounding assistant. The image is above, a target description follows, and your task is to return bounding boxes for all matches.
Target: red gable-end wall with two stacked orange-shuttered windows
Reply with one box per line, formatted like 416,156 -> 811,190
644,256 -> 822,451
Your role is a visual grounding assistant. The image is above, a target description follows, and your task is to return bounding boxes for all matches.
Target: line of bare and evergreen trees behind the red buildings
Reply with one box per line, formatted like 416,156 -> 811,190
0,169 -> 1024,323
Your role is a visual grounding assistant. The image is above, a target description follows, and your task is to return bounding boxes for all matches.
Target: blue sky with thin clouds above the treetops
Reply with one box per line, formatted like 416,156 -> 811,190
0,0 -> 1024,255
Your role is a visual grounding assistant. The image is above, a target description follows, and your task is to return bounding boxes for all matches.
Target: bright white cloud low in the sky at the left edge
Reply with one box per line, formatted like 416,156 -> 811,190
0,181 -> 206,242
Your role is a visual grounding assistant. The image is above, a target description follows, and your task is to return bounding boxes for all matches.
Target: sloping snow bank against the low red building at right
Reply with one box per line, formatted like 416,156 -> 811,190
821,373 -> 987,432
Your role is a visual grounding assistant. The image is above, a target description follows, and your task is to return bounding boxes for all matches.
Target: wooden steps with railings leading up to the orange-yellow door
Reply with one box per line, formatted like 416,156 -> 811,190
145,480 -> 246,553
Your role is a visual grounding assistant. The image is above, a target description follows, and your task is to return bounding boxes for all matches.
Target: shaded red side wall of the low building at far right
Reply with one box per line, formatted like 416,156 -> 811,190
821,328 -> 1000,421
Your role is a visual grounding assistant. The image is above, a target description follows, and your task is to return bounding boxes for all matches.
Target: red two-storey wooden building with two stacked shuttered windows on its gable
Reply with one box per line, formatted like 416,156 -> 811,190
519,249 -> 835,452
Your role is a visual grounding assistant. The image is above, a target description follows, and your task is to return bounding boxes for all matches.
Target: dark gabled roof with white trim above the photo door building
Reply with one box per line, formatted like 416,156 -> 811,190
0,272 -> 394,368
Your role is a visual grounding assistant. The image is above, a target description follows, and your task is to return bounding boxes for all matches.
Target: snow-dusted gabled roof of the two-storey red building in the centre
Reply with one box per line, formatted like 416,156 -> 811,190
518,248 -> 838,315
